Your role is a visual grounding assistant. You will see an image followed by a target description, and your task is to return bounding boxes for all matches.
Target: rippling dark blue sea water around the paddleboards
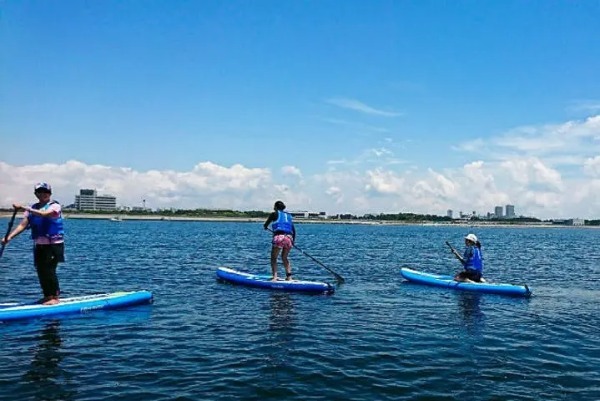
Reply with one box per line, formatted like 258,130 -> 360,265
0,219 -> 600,401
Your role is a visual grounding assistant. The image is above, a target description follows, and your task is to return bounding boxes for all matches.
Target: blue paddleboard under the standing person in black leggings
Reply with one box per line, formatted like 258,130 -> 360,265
0,291 -> 152,322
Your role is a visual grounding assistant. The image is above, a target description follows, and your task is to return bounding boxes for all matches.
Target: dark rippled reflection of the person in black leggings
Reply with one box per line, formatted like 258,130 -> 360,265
23,320 -> 74,400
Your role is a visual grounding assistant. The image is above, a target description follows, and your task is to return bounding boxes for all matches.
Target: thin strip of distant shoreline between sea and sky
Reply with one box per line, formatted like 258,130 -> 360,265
0,212 -> 600,228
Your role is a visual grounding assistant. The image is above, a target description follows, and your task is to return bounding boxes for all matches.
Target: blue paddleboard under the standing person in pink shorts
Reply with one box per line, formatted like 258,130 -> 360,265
217,267 -> 335,294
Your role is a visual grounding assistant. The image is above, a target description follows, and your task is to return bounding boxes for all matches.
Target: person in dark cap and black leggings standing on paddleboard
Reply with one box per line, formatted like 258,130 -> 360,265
2,182 -> 65,305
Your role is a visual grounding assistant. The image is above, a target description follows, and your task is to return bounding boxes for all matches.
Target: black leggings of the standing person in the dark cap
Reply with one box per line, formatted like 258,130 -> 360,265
33,244 -> 65,297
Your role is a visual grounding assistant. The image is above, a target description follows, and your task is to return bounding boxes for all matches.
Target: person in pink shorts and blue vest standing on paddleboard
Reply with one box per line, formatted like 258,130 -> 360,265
263,201 -> 296,281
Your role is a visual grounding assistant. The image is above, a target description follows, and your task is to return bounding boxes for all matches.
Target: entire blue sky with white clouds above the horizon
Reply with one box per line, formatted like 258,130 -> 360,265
0,0 -> 600,219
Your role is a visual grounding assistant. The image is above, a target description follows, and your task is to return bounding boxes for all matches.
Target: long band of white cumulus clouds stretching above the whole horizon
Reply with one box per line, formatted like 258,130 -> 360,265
0,117 -> 600,218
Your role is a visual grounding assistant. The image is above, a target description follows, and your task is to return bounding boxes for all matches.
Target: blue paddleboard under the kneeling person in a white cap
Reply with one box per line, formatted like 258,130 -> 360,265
400,267 -> 531,297
